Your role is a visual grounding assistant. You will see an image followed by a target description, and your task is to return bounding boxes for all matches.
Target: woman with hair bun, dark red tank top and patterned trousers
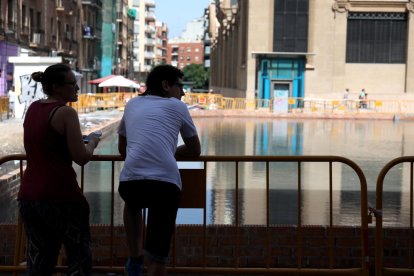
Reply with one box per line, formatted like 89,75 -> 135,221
17,63 -> 99,276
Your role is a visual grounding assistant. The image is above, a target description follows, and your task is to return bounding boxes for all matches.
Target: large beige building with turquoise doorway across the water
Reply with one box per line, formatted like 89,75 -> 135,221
209,0 -> 414,99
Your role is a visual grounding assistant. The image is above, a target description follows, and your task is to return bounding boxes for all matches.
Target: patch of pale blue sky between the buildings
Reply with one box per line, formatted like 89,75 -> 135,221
155,0 -> 210,39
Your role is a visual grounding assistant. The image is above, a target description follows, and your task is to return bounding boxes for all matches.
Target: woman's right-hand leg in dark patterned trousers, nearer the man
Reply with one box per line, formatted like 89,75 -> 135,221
62,201 -> 92,276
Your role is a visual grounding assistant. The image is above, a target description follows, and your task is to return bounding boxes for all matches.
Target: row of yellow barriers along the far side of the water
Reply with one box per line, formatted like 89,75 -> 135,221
64,92 -> 414,114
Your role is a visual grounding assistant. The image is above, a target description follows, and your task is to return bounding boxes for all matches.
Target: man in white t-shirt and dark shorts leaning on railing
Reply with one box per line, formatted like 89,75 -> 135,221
118,65 -> 201,276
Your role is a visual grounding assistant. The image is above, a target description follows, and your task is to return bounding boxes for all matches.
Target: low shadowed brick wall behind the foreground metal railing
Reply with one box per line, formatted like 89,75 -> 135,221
0,224 -> 409,268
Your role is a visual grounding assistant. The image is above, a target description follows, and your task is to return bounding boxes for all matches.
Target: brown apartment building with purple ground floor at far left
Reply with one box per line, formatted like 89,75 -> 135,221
0,0 -> 82,95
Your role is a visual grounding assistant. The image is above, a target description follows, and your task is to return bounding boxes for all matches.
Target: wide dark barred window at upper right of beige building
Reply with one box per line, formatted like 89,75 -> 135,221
346,12 -> 407,63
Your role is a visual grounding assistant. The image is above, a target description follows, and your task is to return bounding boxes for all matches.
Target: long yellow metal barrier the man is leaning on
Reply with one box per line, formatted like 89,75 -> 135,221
0,154 -> 369,275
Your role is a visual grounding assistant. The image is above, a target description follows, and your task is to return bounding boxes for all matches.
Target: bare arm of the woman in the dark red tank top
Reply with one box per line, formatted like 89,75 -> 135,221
50,106 -> 99,166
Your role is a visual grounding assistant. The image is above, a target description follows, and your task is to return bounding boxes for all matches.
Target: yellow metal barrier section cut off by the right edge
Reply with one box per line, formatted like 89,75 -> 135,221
370,156 -> 414,276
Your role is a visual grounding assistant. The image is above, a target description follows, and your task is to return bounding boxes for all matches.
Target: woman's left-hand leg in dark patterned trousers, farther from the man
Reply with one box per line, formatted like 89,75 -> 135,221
19,202 -> 62,276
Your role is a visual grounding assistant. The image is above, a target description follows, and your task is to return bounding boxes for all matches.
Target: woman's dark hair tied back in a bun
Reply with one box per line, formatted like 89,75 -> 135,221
32,63 -> 72,96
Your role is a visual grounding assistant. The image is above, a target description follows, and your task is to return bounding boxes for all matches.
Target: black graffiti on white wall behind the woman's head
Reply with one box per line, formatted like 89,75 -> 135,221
18,74 -> 45,116
